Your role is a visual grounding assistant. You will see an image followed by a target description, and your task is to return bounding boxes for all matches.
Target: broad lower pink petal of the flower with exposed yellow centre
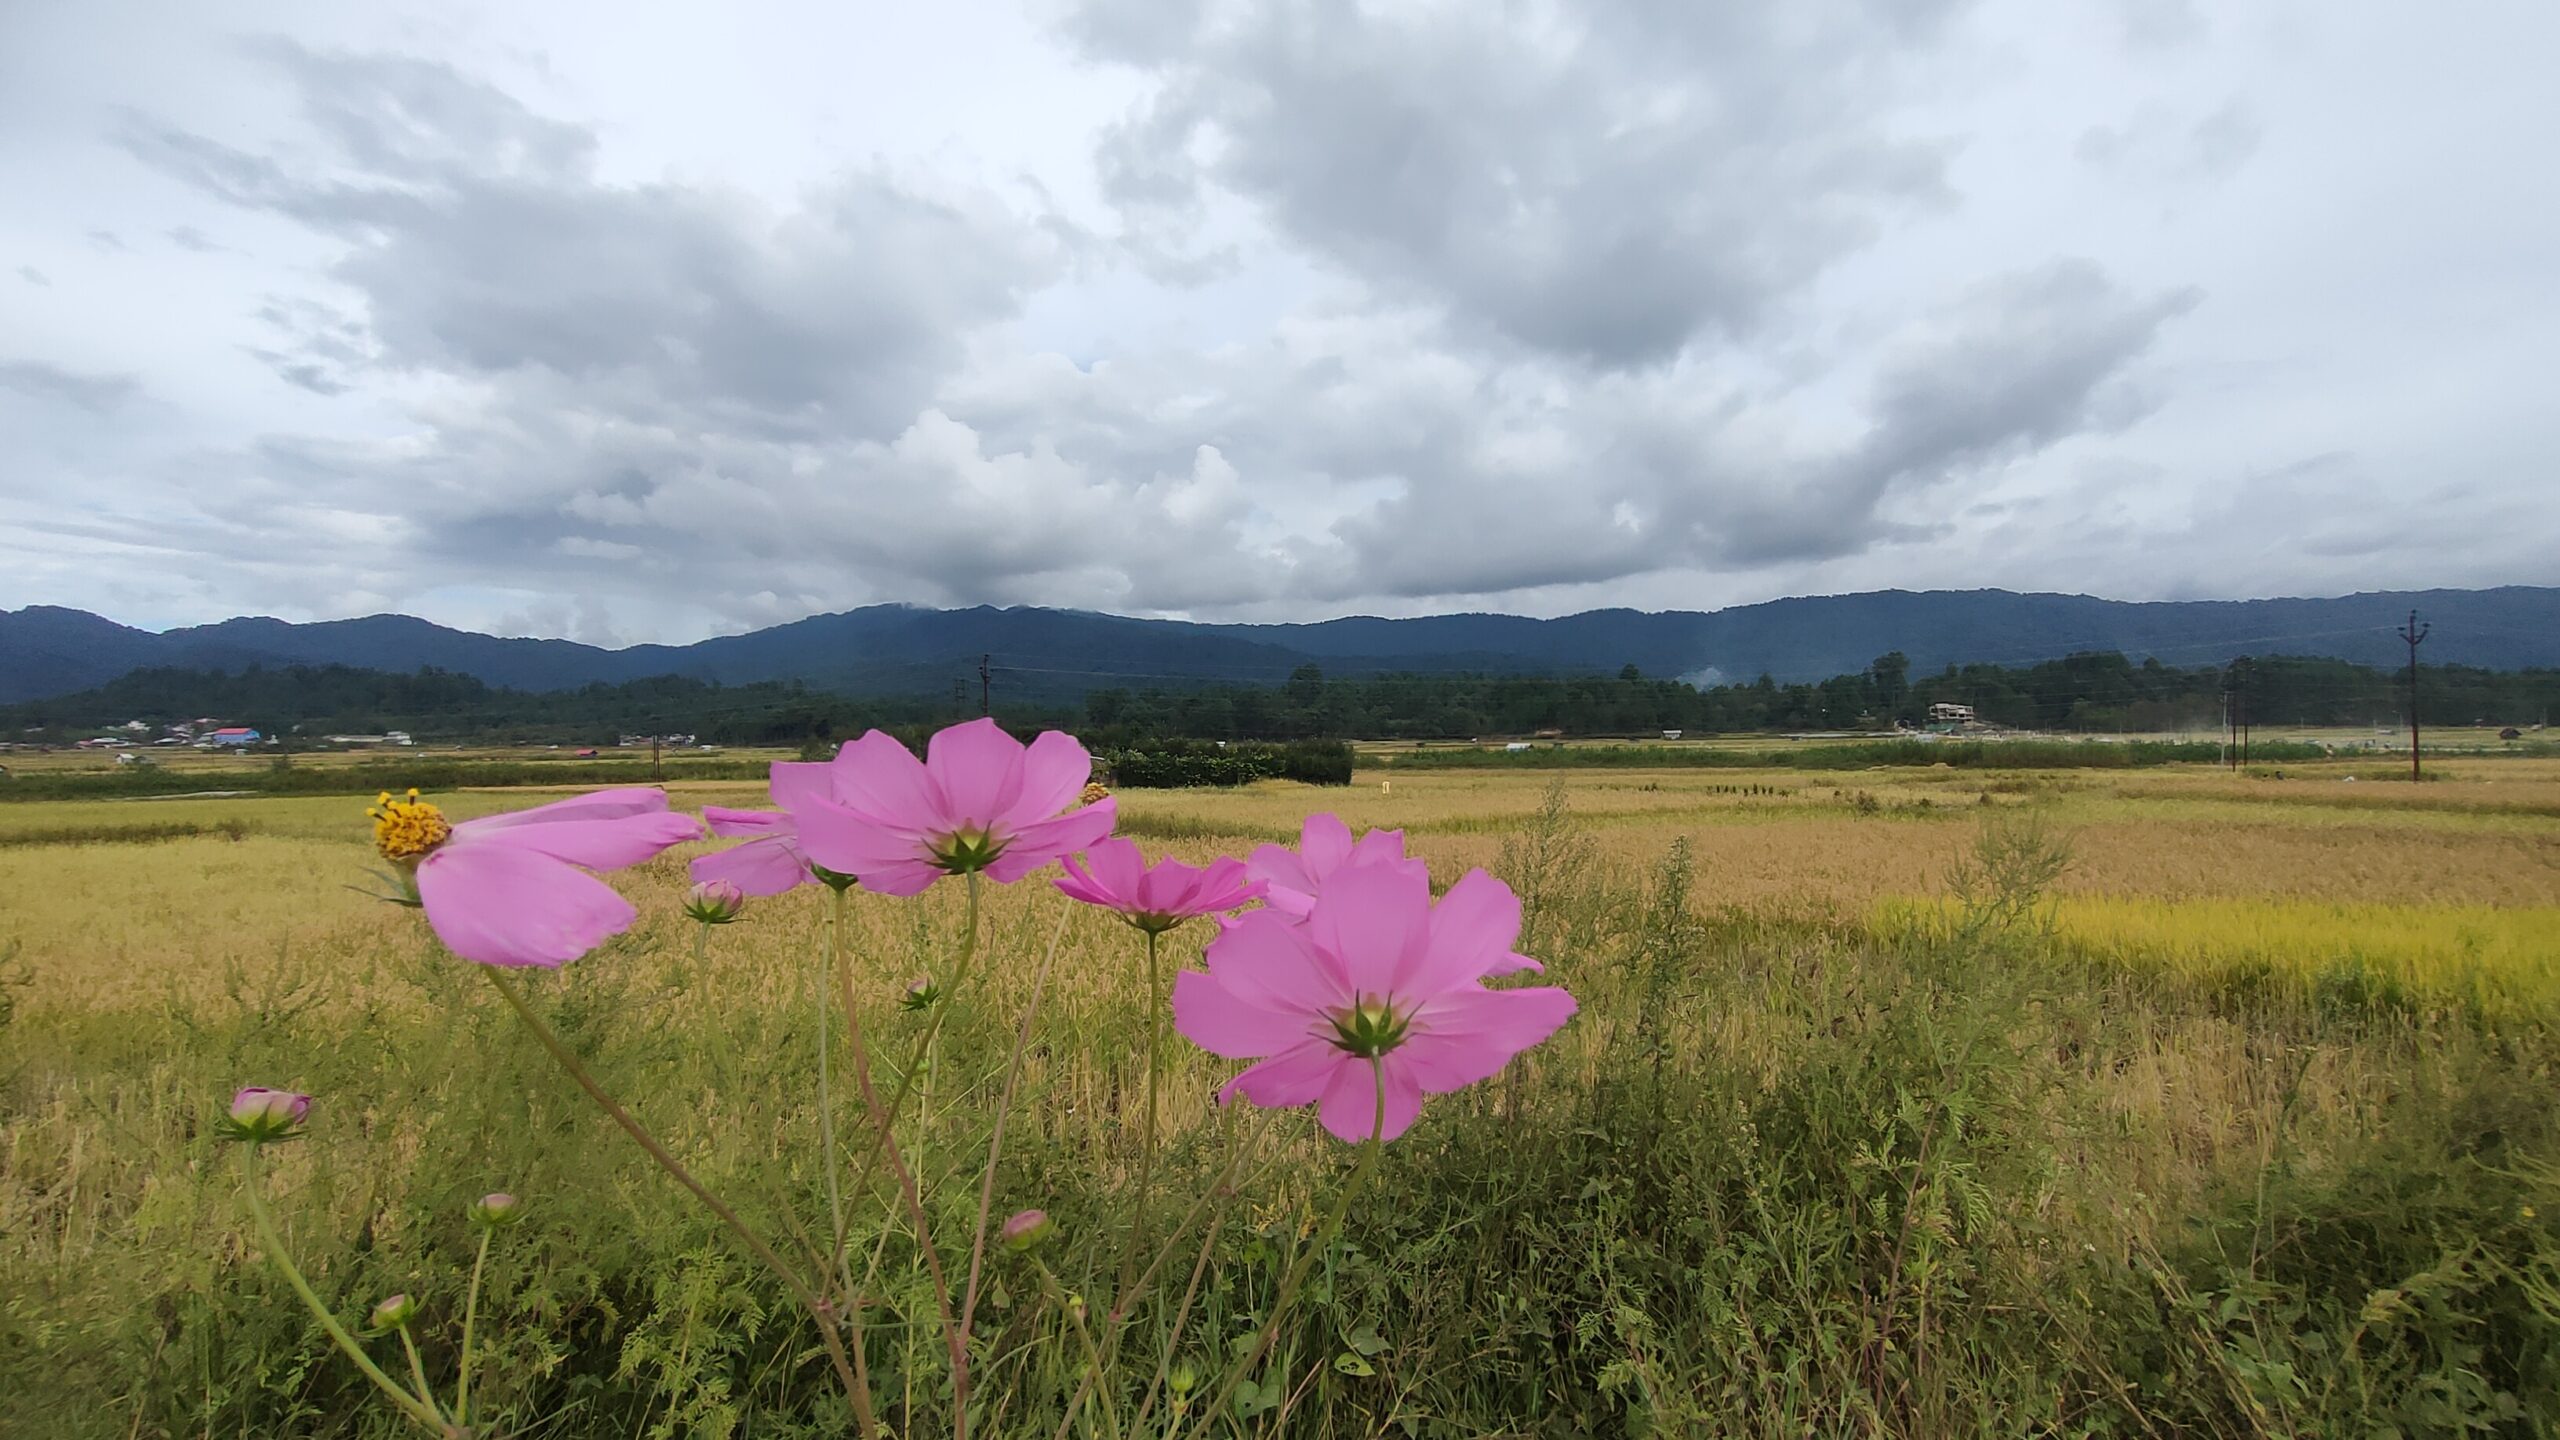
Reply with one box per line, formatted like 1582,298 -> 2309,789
417,843 -> 640,969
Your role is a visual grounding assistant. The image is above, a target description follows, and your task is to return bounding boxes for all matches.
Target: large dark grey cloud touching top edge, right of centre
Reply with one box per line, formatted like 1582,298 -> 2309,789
1073,0 -> 1948,366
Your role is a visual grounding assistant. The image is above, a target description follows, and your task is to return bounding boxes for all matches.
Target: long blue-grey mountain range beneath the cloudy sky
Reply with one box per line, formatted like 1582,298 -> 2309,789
0,587 -> 2560,705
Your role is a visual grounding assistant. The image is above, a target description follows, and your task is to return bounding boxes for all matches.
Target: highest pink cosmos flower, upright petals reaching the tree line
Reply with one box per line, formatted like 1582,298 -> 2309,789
773,720 -> 1119,894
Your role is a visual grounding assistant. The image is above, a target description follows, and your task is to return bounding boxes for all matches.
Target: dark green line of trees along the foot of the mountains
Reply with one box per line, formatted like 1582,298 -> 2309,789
0,653 -> 2560,748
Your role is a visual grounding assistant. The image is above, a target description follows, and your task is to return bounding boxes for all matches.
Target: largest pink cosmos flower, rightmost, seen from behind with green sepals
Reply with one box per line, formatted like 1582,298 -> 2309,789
1172,866 -> 1574,1140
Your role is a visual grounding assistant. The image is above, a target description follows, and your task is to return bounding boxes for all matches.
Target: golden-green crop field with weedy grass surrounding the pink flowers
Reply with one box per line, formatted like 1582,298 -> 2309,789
0,753 -> 2560,1440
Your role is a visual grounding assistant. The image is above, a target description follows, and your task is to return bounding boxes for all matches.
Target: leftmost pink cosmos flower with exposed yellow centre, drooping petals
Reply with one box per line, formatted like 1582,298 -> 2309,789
371,787 -> 701,969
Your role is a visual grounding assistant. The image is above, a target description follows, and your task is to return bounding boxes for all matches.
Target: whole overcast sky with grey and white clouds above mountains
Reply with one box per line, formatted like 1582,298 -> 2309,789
0,0 -> 2560,643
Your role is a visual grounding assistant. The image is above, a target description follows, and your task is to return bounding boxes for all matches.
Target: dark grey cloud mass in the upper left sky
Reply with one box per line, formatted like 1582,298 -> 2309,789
123,44 -> 1055,433
